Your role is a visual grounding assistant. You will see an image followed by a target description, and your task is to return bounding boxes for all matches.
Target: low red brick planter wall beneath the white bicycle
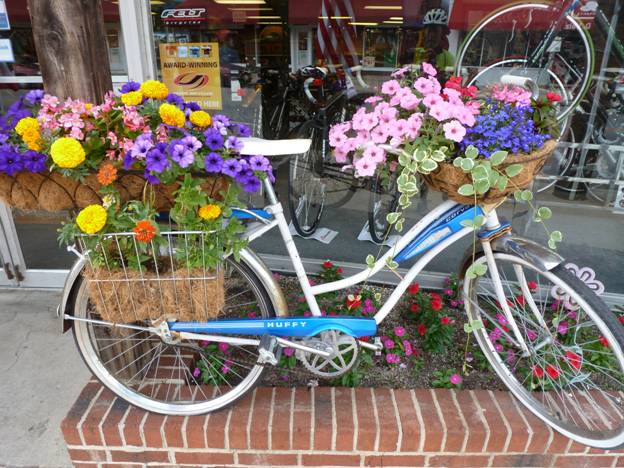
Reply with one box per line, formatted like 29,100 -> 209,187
62,382 -> 624,468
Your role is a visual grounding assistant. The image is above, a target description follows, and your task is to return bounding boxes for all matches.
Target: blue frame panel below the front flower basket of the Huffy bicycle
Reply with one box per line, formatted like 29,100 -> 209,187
394,205 -> 483,263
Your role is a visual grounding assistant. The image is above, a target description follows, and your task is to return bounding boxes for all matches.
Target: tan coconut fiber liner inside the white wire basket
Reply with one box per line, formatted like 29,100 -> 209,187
82,267 -> 225,323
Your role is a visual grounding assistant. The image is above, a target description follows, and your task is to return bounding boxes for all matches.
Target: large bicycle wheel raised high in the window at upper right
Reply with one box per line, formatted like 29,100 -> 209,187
455,3 -> 595,120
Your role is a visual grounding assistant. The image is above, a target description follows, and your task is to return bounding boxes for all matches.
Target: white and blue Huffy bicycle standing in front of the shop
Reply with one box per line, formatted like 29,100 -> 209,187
60,138 -> 624,449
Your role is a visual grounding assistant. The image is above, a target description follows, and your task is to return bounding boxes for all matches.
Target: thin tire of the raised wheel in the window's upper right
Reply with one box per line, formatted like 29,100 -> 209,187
455,2 -> 595,120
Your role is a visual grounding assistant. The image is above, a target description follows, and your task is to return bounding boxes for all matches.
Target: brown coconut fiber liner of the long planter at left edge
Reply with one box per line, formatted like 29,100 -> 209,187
0,171 -> 228,211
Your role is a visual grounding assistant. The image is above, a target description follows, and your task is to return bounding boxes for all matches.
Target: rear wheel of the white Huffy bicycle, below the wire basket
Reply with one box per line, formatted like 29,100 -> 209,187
73,254 -> 275,416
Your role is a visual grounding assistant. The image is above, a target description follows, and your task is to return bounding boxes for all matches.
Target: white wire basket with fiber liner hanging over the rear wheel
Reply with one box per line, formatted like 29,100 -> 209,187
79,231 -> 225,323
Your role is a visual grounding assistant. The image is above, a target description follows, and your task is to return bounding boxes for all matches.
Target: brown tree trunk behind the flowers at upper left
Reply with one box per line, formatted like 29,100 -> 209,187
28,0 -> 113,103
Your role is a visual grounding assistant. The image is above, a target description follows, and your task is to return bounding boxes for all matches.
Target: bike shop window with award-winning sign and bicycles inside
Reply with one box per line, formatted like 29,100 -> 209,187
151,0 -> 624,294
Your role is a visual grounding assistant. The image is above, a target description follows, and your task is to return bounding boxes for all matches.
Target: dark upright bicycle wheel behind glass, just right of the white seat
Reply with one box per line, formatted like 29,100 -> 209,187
288,121 -> 328,237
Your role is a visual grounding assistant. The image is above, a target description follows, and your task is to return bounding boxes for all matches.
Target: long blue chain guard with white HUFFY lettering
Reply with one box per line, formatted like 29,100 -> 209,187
169,316 -> 377,338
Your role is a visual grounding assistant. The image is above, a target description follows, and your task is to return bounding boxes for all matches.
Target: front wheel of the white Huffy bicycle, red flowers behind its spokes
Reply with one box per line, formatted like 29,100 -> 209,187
463,253 -> 624,449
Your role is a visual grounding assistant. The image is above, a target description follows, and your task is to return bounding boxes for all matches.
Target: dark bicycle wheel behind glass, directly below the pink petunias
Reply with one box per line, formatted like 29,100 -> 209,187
368,172 -> 399,244
